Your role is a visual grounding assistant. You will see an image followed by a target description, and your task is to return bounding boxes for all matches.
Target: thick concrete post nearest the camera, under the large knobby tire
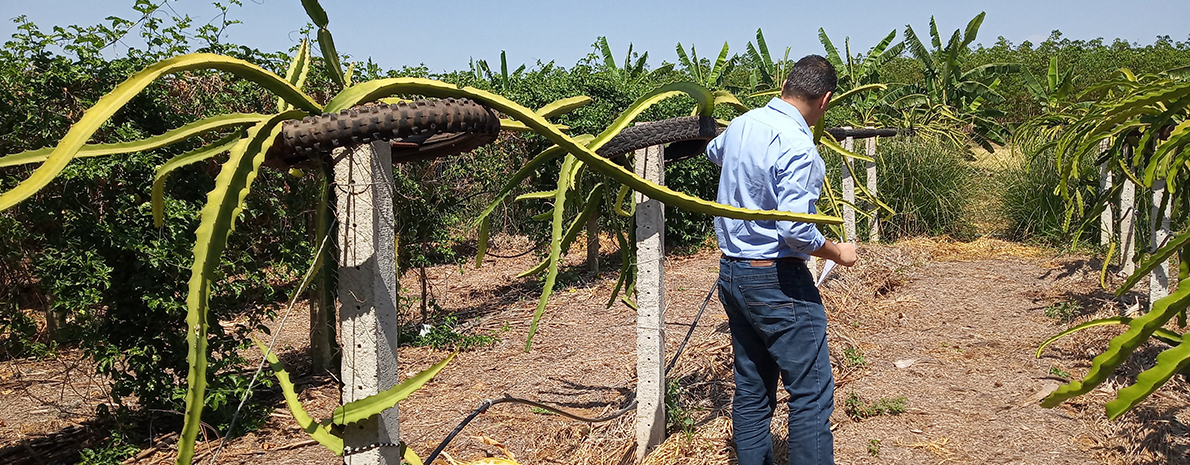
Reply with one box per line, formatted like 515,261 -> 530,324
333,140 -> 401,465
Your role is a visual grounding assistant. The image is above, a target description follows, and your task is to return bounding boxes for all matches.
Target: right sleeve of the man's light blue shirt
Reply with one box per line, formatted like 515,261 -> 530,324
774,138 -> 826,255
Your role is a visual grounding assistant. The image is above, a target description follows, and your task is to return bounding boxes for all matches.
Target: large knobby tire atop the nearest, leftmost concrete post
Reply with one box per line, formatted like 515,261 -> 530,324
265,99 -> 500,166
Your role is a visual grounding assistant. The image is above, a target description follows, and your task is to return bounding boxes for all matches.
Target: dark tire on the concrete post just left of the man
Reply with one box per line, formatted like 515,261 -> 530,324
595,117 -> 724,163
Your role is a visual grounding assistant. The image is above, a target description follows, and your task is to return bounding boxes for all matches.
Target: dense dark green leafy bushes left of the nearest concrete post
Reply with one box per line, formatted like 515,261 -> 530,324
0,10 -> 308,444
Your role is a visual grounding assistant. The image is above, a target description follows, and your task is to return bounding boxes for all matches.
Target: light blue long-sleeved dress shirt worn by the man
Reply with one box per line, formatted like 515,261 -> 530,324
707,99 -> 826,259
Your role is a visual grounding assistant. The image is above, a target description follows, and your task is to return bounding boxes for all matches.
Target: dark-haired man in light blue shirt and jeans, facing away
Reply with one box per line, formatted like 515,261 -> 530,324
707,55 -> 856,465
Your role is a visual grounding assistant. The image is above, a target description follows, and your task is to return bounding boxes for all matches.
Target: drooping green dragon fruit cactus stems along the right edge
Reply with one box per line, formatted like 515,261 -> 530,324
1039,70 -> 1190,419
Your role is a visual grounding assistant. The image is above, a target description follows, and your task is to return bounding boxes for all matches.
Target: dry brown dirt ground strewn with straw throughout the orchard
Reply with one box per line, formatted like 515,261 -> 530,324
0,240 -> 1190,464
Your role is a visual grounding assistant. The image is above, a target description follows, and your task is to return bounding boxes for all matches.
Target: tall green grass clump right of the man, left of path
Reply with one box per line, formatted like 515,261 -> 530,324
857,137 -> 973,240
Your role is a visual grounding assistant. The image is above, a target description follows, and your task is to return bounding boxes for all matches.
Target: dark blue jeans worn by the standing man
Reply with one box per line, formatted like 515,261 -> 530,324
719,259 -> 834,465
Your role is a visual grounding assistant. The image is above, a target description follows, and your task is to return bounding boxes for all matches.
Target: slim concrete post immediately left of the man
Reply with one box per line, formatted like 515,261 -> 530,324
635,145 -> 665,463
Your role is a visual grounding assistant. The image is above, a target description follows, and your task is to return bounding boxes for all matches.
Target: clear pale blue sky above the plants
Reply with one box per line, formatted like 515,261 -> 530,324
0,0 -> 1190,71
